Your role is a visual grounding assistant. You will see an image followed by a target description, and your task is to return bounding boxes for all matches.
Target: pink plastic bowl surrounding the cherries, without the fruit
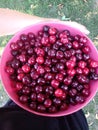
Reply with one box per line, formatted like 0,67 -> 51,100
0,22 -> 98,117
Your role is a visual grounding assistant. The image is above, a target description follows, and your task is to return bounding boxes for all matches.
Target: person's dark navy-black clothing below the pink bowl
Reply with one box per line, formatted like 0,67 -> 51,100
0,100 -> 88,130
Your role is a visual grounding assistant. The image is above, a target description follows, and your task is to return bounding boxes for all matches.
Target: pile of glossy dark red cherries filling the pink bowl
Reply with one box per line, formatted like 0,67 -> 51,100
5,25 -> 98,113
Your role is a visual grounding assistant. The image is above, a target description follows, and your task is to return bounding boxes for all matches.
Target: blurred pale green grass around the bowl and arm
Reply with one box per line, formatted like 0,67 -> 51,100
0,0 -> 98,130
